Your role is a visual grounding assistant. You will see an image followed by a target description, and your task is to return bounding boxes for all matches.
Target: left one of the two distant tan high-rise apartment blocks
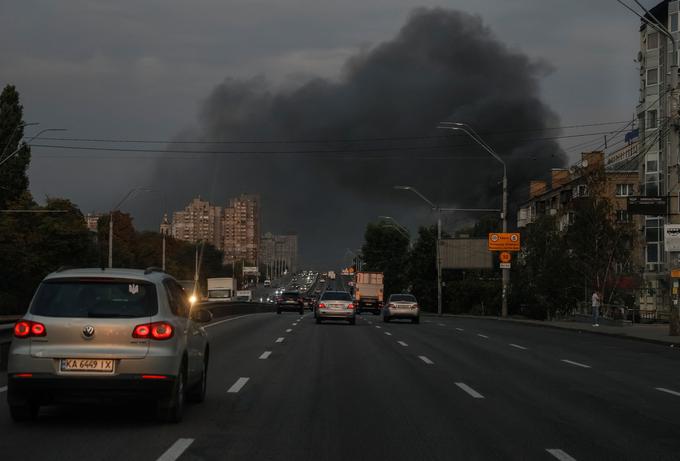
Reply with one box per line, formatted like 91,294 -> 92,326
170,197 -> 223,250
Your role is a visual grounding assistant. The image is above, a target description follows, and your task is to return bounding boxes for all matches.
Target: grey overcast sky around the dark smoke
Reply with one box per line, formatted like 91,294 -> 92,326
0,0 -> 656,264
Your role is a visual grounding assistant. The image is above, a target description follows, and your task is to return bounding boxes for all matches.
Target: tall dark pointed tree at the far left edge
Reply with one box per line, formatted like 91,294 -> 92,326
0,85 -> 31,209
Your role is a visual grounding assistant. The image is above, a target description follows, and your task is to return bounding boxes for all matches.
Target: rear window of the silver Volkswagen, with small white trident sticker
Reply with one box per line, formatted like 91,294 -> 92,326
31,279 -> 158,318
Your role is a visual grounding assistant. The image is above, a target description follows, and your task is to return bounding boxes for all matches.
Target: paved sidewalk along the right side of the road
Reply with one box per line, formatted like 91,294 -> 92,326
438,315 -> 680,346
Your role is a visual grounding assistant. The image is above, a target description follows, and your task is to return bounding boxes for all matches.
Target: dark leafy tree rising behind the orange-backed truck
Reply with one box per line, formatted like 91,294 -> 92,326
361,220 -> 409,296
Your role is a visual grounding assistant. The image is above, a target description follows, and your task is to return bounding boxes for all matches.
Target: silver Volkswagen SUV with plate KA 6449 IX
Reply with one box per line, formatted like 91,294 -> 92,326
7,268 -> 212,422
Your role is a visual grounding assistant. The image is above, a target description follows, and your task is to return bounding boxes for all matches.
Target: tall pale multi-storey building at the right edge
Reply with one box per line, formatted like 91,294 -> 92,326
636,0 -> 680,316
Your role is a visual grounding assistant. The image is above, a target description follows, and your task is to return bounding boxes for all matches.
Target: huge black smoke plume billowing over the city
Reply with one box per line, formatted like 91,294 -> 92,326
157,8 -> 565,268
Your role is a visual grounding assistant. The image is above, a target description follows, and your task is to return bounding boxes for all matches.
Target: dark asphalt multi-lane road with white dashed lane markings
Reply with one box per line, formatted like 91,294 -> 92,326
0,313 -> 680,461
